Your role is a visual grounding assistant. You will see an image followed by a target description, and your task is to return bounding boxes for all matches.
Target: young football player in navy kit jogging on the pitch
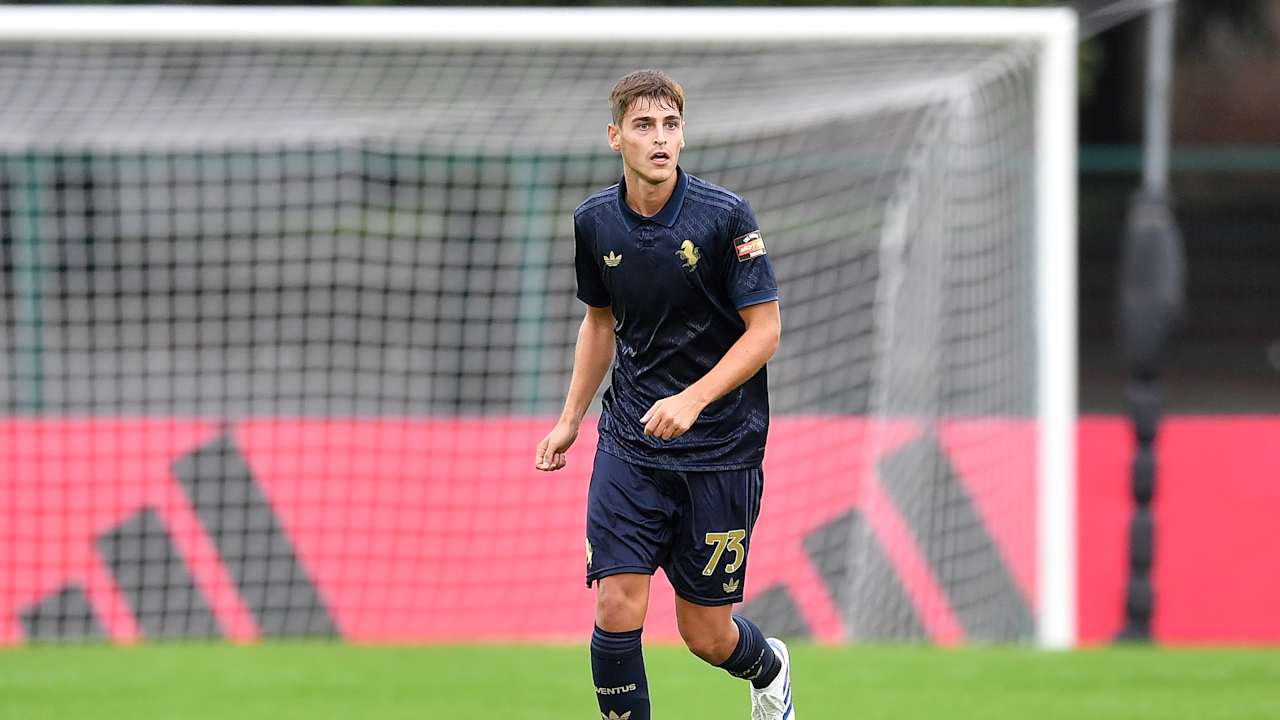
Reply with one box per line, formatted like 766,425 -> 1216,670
535,70 -> 795,720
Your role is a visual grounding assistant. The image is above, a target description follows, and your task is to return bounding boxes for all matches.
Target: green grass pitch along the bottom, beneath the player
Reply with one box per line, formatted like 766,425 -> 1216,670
0,643 -> 1280,720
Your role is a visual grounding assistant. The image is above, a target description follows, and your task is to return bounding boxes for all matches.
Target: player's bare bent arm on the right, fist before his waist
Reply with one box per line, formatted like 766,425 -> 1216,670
640,300 -> 782,439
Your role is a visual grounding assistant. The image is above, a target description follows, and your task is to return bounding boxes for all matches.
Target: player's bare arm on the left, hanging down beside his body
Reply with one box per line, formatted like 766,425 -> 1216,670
534,306 -> 613,471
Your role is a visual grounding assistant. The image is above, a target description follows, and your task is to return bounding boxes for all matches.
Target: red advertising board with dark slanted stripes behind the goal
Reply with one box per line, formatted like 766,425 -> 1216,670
0,418 -> 1280,643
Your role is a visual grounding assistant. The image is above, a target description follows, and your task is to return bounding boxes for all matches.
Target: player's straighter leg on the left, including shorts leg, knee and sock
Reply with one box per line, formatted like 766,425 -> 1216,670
586,452 -> 676,720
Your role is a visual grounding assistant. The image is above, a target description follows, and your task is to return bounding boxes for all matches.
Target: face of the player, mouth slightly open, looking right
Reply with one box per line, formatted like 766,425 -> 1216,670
609,97 -> 685,184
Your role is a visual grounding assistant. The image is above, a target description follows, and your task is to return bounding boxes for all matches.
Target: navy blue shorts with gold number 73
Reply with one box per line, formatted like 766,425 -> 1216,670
586,451 -> 764,605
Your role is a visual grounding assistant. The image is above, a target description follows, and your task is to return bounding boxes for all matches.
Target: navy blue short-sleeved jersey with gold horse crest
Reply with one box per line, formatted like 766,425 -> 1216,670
573,168 -> 778,470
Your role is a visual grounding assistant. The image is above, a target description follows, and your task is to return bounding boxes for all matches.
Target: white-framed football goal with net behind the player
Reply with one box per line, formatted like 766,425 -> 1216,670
0,8 -> 1074,644
